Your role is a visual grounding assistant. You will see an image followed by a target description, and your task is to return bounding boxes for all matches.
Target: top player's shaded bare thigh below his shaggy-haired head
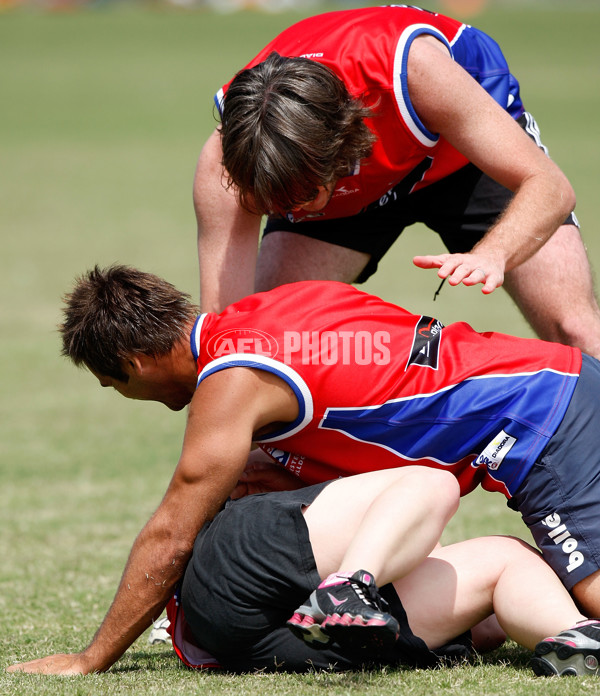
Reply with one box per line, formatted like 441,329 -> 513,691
256,232 -> 370,292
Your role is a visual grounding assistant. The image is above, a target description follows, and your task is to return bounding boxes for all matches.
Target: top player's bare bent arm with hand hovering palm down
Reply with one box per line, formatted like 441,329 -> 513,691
408,37 -> 575,292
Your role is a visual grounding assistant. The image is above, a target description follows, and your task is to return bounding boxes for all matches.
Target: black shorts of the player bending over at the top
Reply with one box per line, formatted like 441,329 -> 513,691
264,112 -> 577,283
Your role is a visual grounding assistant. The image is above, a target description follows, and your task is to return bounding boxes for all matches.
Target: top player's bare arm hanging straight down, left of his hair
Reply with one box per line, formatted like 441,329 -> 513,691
194,131 -> 261,312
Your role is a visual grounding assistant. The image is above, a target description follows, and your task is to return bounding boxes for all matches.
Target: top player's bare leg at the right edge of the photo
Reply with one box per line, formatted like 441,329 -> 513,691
504,225 -> 600,358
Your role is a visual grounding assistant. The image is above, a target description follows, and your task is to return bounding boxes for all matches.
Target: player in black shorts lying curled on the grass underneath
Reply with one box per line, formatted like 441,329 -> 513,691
168,466 -> 600,675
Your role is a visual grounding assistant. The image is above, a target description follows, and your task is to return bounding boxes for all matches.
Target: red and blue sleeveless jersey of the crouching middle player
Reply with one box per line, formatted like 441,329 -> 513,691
191,281 -> 581,497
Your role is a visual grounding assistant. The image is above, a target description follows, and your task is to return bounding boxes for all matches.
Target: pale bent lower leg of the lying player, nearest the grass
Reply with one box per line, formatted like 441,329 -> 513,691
394,537 -> 585,649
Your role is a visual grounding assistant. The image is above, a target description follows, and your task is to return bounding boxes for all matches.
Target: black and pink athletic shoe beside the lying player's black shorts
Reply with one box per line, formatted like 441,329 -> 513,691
287,570 -> 400,650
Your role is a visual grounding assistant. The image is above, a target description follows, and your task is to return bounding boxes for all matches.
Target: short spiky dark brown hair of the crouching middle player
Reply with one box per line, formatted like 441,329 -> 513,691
59,265 -> 198,382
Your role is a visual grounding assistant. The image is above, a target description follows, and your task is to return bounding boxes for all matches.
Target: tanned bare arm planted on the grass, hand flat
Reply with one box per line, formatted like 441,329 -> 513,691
9,368 -> 298,674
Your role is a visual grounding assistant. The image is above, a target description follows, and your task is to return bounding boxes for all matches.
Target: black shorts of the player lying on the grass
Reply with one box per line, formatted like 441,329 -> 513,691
181,483 -> 448,672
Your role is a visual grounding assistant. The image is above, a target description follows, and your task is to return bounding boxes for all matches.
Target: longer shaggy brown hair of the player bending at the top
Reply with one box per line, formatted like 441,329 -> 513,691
221,53 -> 375,214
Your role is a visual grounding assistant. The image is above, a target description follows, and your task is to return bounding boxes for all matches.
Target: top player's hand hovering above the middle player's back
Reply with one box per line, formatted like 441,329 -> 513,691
413,253 -> 504,295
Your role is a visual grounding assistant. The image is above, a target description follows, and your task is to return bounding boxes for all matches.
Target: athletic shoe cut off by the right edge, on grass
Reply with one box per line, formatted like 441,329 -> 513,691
531,621 -> 600,677
